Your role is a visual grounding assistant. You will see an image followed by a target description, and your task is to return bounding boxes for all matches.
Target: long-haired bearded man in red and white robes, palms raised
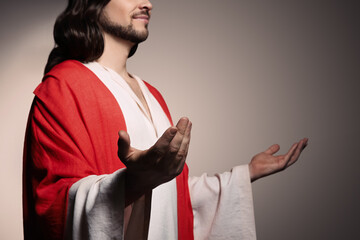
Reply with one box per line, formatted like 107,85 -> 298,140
24,0 -> 307,239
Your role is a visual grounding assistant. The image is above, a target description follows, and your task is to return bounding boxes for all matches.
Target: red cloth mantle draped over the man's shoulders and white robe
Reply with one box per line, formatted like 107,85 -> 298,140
23,60 -> 193,240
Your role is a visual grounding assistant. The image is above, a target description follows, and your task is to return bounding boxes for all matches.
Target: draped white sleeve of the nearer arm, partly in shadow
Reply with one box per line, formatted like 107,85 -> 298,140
64,169 -> 151,240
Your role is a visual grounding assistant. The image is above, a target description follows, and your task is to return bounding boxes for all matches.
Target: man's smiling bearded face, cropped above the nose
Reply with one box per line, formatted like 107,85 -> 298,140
99,0 -> 152,43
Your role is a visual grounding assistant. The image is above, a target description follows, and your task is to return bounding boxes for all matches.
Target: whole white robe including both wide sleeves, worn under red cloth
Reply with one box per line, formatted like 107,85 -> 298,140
65,62 -> 256,240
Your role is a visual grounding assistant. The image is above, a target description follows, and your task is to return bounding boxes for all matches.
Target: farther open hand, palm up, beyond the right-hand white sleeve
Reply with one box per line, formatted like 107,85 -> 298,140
249,138 -> 308,182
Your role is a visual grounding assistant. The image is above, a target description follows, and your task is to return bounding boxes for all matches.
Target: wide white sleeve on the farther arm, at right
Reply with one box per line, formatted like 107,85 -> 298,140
189,165 -> 256,240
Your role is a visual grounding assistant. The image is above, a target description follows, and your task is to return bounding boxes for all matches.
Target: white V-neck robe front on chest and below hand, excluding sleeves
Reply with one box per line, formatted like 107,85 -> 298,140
85,62 -> 177,240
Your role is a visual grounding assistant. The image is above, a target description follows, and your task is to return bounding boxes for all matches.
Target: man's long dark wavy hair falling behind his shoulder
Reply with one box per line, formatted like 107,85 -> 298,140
45,0 -> 137,74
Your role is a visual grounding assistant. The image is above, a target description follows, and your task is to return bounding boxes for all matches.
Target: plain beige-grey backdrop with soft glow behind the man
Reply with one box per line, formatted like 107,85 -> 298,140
0,0 -> 360,240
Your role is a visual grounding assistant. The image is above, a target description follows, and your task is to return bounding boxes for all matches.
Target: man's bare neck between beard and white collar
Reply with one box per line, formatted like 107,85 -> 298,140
97,33 -> 134,78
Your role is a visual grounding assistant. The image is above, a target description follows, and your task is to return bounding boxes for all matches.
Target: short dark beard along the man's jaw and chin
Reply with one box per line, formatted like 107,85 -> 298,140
99,14 -> 149,44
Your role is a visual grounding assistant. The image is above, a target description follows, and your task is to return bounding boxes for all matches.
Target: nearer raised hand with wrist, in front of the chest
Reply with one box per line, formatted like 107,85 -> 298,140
118,117 -> 192,205
